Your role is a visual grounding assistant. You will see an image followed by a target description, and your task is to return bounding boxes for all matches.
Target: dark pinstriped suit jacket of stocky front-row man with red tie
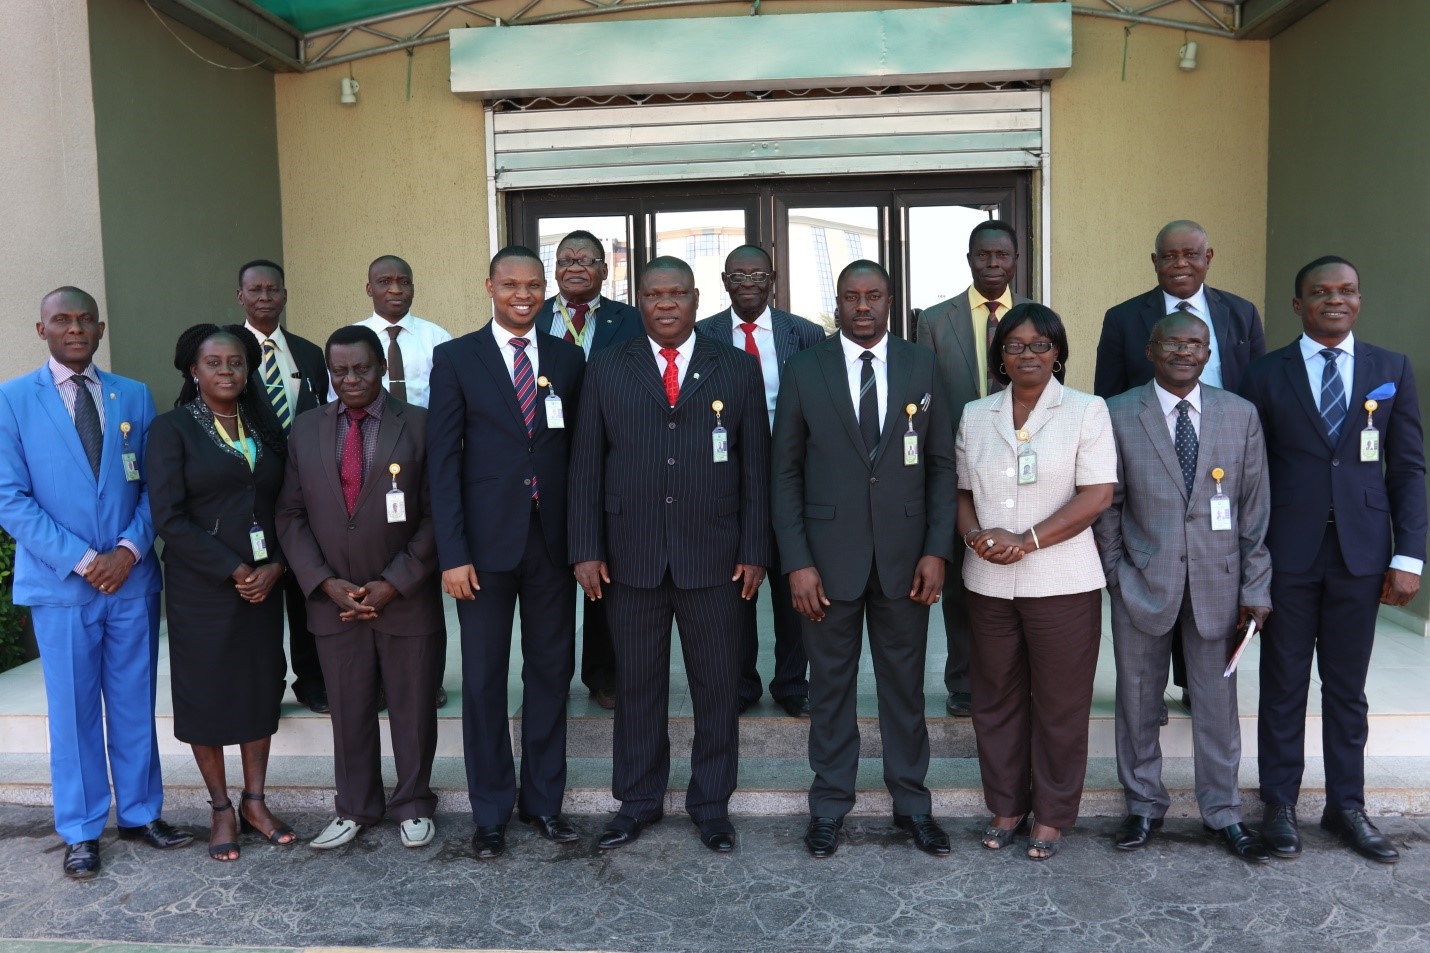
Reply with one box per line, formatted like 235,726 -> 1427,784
571,335 -> 769,588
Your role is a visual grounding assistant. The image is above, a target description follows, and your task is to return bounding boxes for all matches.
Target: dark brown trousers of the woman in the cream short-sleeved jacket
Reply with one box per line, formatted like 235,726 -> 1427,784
968,590 -> 1103,827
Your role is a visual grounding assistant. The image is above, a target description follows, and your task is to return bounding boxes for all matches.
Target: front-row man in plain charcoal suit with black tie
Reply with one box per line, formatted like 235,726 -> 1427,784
771,260 -> 957,857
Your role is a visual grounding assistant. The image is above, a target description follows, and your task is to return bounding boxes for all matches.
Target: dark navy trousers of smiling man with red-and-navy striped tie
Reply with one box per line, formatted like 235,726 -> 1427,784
456,511 -> 576,826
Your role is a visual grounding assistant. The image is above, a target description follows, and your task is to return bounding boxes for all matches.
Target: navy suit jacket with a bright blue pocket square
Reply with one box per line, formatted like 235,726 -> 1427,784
1241,338 -> 1426,575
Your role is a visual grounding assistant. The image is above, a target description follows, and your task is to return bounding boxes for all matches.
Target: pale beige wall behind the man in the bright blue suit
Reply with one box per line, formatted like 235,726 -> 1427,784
0,0 -> 109,379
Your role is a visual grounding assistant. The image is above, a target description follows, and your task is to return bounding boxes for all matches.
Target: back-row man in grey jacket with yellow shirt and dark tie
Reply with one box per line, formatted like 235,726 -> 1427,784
915,219 -> 1031,718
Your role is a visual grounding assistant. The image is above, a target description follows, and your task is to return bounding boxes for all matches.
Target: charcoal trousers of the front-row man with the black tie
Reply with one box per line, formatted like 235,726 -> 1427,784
801,570 -> 932,817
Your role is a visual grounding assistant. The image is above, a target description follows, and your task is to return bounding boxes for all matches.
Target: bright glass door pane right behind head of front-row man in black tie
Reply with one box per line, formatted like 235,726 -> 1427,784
779,206 -> 884,331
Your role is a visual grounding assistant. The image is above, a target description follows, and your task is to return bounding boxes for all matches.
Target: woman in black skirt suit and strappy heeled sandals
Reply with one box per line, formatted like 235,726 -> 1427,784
147,325 -> 297,861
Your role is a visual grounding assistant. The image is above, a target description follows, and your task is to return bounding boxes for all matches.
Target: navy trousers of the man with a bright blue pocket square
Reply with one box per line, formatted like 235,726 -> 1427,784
1264,524 -> 1384,810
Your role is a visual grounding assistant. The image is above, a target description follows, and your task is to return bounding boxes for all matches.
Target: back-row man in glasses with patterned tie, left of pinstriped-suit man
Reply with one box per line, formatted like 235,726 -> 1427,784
536,230 -> 644,710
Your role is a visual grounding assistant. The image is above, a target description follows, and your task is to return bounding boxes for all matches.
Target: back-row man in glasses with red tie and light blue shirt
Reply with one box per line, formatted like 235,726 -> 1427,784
695,245 -> 824,718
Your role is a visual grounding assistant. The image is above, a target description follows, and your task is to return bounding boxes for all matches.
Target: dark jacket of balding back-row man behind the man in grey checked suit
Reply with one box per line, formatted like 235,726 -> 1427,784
1093,285 -> 1266,398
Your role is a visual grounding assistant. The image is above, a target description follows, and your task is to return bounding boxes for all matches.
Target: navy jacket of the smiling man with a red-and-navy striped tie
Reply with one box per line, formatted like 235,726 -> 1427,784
428,321 -> 586,574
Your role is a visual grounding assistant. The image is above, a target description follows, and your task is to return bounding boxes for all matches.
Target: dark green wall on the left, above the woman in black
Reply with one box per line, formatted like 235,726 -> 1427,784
89,0 -> 283,411
